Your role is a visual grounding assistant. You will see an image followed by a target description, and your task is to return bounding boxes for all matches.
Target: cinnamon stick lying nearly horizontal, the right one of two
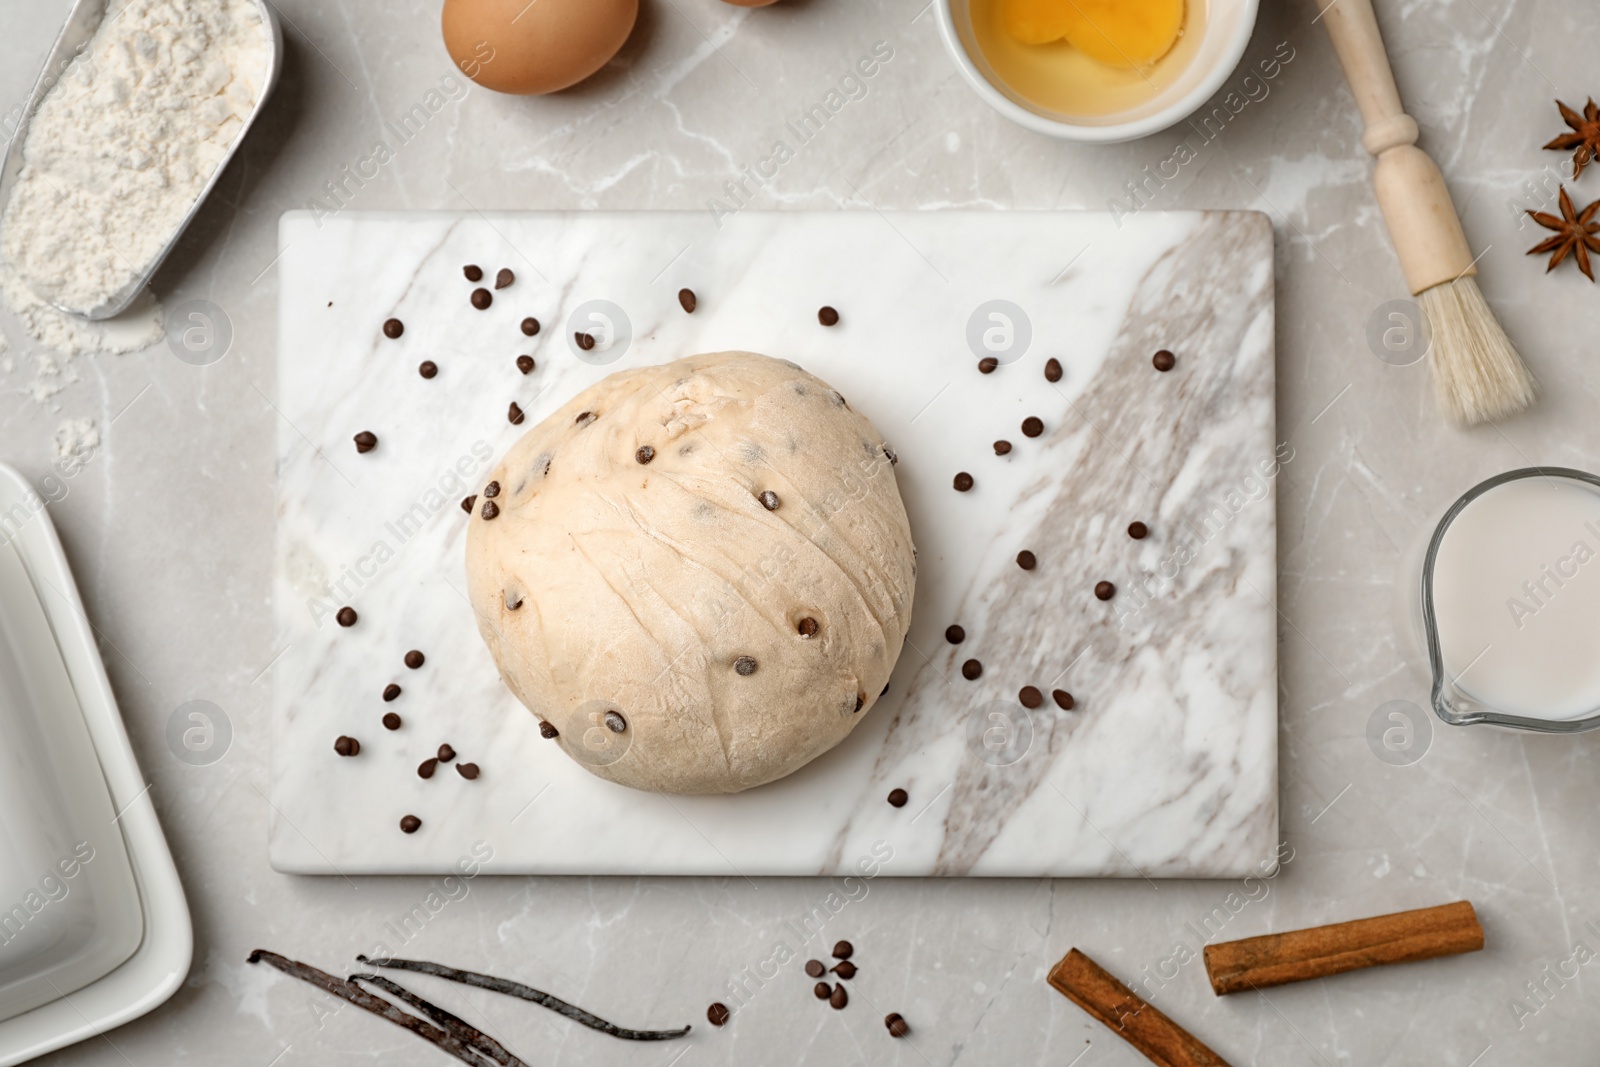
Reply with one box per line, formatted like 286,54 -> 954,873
1205,901 -> 1483,997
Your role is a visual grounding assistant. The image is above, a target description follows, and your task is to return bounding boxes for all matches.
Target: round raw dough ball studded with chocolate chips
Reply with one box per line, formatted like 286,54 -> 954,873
467,352 -> 915,793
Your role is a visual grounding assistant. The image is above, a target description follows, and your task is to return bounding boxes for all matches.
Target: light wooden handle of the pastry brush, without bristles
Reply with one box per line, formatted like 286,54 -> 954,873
1322,0 -> 1477,294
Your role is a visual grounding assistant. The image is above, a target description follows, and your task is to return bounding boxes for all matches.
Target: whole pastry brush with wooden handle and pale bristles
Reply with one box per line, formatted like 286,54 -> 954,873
1320,0 -> 1534,426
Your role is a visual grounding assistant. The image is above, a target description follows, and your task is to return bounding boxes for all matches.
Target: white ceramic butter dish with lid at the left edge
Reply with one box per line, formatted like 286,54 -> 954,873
0,464 -> 194,1067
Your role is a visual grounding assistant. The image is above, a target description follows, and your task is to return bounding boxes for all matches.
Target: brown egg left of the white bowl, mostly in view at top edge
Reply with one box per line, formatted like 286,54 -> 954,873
440,0 -> 638,96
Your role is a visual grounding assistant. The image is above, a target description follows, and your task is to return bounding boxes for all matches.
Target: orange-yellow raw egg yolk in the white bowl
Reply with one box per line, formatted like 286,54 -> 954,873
1005,0 -> 1184,67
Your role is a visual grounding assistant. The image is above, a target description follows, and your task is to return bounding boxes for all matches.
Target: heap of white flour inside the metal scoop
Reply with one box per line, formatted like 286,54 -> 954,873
0,0 -> 269,313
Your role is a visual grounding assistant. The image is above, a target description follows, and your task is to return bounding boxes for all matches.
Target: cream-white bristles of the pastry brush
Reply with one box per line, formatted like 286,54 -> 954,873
1418,277 -> 1538,426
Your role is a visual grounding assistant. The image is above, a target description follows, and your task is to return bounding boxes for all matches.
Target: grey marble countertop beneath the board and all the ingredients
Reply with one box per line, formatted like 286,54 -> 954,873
0,0 -> 1600,1067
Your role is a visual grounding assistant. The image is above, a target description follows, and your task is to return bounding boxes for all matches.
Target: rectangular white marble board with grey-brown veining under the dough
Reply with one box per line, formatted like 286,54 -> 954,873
270,211 -> 1283,878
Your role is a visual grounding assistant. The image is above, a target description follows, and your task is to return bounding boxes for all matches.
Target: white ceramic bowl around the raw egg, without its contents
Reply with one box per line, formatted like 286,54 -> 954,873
938,0 -> 1259,144
